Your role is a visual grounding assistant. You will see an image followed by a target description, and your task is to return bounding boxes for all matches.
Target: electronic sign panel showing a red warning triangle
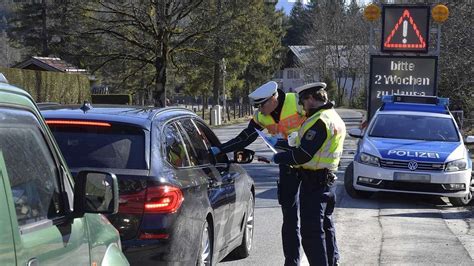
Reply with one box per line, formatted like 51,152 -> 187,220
382,5 -> 430,53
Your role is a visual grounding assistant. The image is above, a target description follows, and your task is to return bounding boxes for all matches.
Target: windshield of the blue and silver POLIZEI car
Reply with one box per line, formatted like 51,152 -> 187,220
369,114 -> 459,142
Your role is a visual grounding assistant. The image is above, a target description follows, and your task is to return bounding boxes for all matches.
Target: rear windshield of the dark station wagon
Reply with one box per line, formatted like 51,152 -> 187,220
49,124 -> 146,169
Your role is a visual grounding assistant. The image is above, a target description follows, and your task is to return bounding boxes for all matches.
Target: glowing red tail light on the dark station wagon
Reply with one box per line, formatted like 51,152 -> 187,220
145,186 -> 184,213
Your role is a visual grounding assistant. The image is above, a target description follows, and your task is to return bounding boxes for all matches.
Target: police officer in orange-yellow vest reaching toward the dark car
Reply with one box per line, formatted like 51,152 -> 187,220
211,81 -> 305,265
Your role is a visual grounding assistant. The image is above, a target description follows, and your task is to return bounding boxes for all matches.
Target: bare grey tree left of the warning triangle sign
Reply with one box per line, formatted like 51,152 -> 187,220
305,1 -> 368,105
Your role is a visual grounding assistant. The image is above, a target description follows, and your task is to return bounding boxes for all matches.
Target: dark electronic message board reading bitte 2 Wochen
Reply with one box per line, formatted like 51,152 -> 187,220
368,55 -> 438,118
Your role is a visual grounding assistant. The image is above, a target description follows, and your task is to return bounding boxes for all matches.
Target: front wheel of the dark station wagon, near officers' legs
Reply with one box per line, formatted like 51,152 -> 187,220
232,193 -> 255,259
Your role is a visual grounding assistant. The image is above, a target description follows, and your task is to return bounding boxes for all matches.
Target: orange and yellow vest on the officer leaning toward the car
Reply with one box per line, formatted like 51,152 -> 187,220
253,92 -> 305,138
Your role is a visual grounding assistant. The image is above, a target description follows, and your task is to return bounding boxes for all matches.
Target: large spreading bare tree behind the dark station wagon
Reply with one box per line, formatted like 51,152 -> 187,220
83,0 -> 221,106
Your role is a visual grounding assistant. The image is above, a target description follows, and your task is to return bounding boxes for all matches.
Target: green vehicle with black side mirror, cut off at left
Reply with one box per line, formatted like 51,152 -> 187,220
0,74 -> 128,265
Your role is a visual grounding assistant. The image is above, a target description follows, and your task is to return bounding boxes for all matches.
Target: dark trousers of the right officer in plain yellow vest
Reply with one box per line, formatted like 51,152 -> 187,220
298,171 -> 339,265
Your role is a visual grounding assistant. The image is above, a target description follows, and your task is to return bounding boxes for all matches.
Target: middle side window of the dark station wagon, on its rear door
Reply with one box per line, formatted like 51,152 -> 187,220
180,119 -> 211,165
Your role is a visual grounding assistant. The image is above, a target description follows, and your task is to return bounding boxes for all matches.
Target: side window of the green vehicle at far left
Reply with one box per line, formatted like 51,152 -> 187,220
0,110 -> 64,226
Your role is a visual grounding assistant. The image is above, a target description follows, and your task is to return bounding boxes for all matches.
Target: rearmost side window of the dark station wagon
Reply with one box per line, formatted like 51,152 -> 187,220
163,123 -> 193,167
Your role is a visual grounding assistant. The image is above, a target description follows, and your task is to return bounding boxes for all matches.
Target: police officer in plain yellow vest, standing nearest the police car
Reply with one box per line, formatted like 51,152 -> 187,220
272,82 -> 346,265
